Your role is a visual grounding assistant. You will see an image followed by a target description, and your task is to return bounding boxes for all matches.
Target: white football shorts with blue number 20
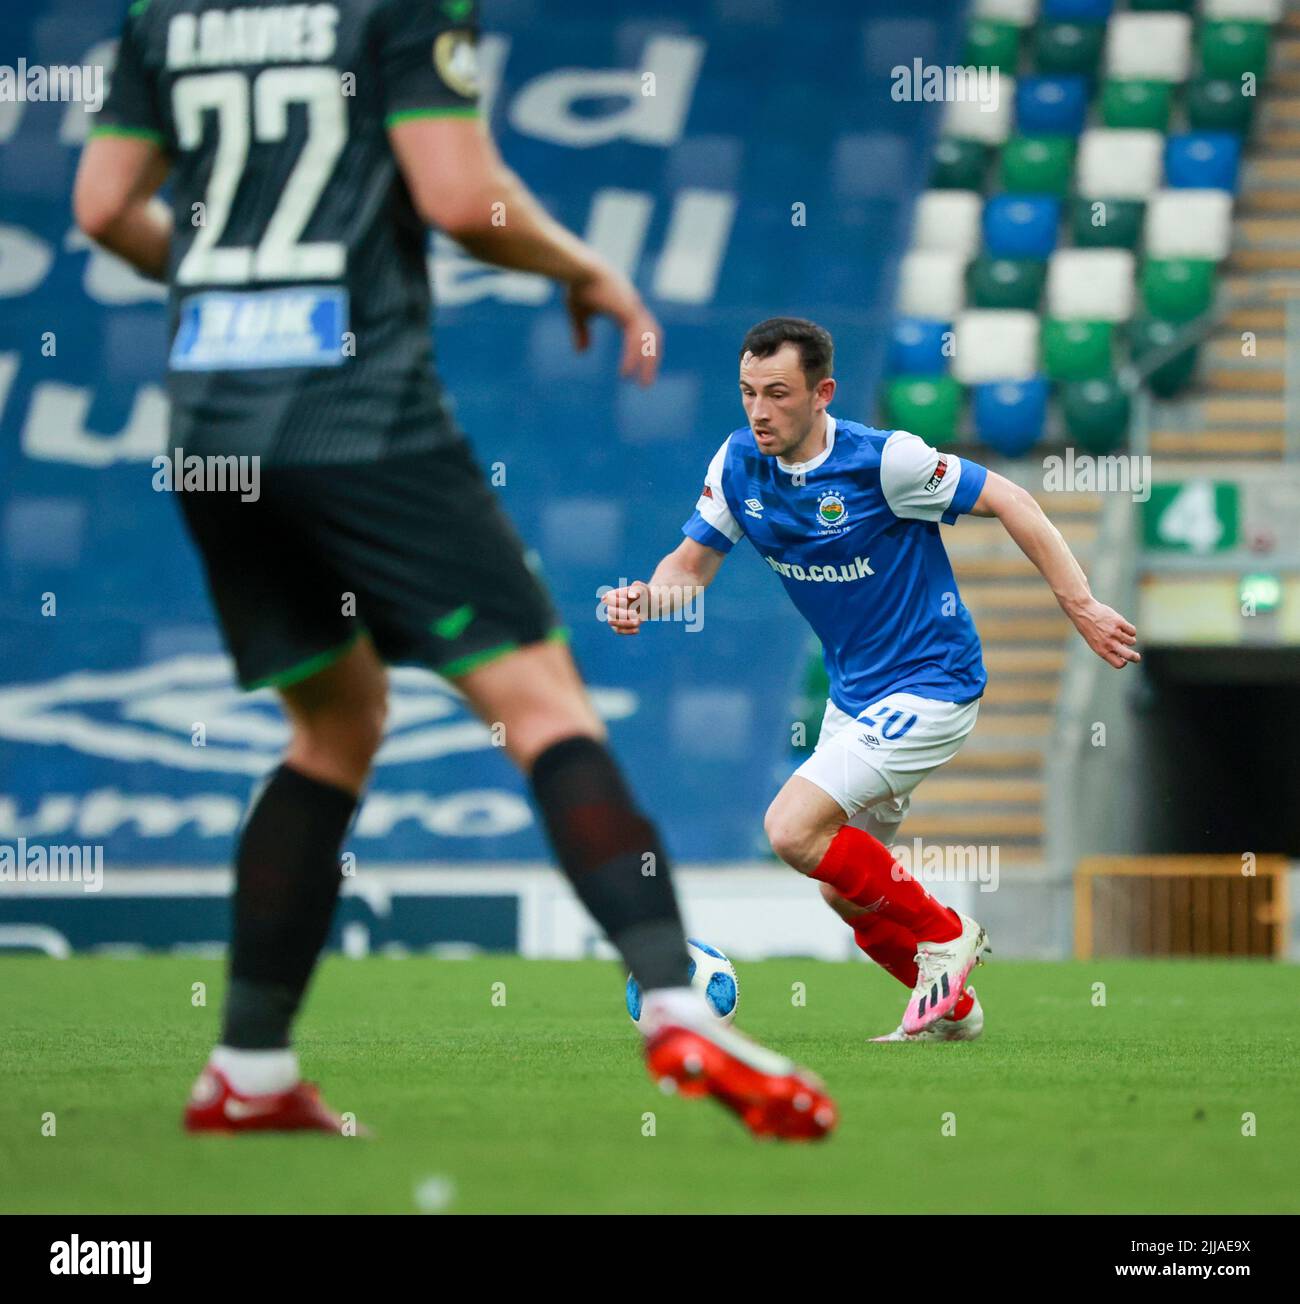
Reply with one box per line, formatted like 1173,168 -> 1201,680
795,692 -> 979,841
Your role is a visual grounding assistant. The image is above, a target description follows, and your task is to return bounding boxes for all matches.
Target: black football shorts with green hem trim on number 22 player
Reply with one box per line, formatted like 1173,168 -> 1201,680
179,441 -> 567,690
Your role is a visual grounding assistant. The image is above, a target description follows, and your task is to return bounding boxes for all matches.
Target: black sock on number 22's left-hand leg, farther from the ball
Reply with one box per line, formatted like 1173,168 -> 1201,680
222,765 -> 357,1050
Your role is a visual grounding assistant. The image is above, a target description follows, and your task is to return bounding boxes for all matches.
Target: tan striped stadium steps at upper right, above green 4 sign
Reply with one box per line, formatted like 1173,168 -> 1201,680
1150,3 -> 1300,462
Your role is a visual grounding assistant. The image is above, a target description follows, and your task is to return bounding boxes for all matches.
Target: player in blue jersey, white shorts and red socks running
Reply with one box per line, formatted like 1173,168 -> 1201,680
604,317 -> 1140,1041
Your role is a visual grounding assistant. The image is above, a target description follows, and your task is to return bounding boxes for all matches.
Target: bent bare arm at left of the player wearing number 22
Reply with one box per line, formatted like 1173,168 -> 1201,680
72,136 -> 172,280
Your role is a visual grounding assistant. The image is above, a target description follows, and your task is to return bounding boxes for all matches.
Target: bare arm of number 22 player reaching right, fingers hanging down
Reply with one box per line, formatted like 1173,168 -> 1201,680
389,117 -> 662,385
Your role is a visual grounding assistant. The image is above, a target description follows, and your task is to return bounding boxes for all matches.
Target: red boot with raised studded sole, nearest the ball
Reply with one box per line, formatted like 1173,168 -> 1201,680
645,1024 -> 838,1141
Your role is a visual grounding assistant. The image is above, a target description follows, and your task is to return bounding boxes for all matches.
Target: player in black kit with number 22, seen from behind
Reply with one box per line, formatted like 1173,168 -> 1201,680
74,0 -> 836,1138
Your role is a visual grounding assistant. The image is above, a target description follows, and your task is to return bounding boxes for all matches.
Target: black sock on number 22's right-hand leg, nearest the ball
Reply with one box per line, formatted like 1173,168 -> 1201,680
529,735 -> 690,991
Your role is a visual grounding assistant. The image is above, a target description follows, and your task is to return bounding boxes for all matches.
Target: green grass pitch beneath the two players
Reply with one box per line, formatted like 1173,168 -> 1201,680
0,956 -> 1300,1213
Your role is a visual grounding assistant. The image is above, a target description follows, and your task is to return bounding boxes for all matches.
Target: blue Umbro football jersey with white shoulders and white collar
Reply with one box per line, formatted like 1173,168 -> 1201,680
682,412 -> 988,716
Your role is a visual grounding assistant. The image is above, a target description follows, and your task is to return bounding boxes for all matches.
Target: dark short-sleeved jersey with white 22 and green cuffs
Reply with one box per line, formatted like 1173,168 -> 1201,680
94,0 -> 479,464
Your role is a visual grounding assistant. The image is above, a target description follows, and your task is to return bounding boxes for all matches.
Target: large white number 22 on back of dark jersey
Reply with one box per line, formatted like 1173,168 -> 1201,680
172,68 -> 348,286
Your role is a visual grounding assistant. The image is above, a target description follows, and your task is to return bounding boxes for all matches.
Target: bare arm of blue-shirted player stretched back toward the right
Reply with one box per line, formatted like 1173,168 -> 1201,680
971,471 -> 1142,670
